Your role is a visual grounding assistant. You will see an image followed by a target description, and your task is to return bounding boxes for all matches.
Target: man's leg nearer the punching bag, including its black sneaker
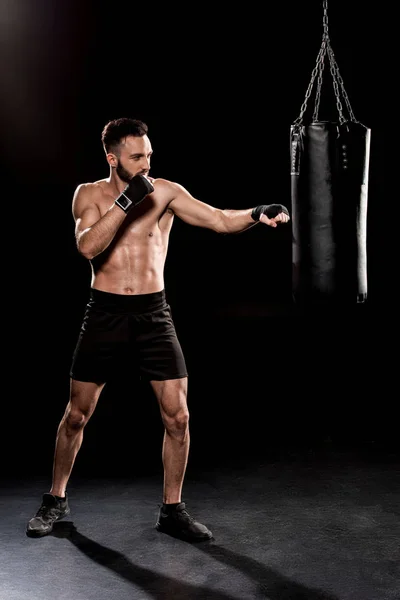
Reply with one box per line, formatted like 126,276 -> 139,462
151,377 -> 212,542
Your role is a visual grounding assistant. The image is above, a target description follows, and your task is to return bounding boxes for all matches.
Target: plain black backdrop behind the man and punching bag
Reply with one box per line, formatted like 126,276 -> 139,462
1,1 -> 390,475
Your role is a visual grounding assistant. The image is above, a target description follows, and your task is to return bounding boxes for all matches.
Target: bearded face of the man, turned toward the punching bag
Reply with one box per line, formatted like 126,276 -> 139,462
107,135 -> 153,183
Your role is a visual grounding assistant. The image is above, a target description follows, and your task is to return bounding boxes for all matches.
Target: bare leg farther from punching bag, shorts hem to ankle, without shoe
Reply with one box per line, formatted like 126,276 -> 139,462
50,379 -> 104,497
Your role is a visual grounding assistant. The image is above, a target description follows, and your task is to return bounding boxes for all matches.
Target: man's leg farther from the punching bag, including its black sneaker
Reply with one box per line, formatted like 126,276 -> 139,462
26,379 -> 104,537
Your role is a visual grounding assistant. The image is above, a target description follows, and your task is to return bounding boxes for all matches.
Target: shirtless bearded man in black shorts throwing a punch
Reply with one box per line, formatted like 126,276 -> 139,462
26,118 -> 289,541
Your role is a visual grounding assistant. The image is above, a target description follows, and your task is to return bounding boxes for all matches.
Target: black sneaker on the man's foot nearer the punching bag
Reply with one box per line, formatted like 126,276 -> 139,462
156,502 -> 213,542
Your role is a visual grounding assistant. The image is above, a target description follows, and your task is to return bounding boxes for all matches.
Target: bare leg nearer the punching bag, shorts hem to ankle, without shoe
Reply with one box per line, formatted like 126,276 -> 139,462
151,377 -> 190,504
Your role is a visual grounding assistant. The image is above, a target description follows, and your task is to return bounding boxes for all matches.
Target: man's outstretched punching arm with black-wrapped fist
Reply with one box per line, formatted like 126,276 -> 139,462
169,182 -> 290,233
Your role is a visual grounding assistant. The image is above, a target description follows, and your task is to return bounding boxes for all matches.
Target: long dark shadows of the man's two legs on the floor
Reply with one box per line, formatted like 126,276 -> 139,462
52,522 -> 338,600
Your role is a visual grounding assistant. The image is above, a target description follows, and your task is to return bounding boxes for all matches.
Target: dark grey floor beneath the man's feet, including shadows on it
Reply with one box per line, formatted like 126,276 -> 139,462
0,447 -> 400,600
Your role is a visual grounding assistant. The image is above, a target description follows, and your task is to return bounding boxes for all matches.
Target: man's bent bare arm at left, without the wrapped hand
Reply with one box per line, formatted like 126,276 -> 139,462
72,184 -> 126,260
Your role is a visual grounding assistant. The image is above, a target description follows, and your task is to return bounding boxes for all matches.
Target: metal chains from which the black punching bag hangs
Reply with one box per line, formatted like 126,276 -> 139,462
293,0 -> 358,125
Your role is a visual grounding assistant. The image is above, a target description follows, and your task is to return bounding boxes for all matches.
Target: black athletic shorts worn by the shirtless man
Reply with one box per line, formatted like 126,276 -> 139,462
70,288 -> 187,383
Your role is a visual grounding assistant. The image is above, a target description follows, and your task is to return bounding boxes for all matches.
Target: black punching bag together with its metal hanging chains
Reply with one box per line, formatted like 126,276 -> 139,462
290,0 -> 371,308
